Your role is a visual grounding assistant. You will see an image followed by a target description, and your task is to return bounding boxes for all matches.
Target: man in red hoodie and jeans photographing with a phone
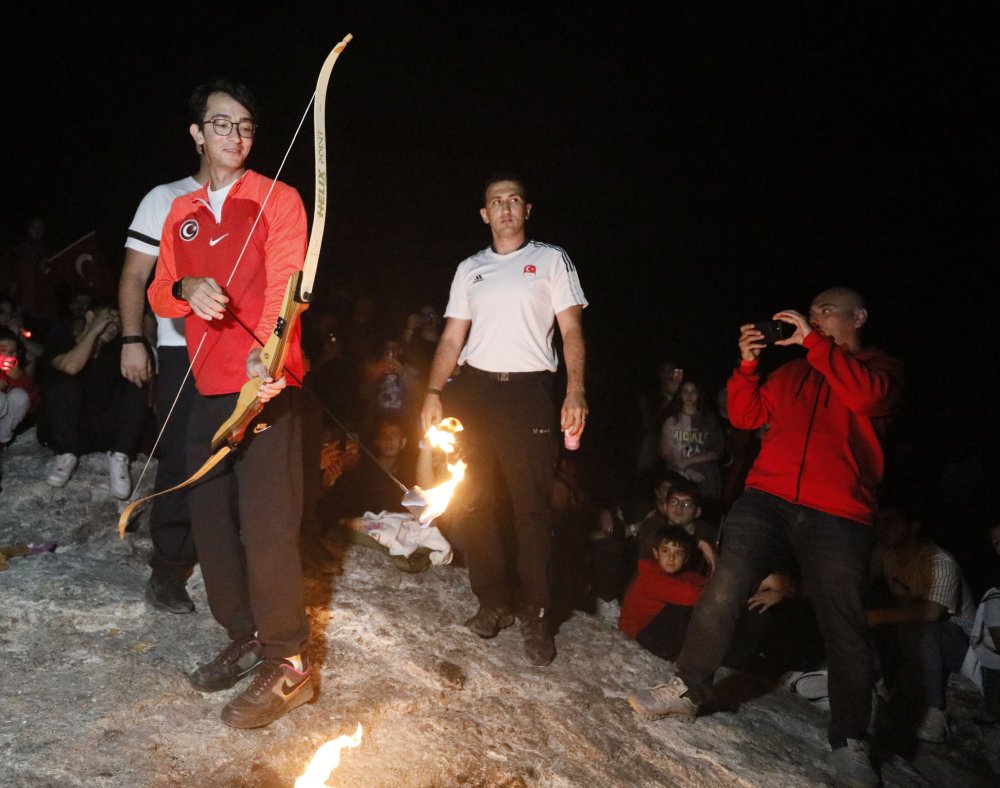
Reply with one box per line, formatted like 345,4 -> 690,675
629,287 -> 902,785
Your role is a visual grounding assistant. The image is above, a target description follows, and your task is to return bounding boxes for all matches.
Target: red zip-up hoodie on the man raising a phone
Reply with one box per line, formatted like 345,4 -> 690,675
727,331 -> 903,525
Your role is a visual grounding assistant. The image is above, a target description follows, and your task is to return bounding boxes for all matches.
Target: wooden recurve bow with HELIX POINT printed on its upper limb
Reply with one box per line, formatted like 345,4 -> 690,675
118,38 -> 353,539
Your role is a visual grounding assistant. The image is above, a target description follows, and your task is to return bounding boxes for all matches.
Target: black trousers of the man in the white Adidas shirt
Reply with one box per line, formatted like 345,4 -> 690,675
445,374 -> 559,608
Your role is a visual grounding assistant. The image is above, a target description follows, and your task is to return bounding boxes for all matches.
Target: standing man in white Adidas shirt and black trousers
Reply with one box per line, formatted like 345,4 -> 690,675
422,175 -> 587,665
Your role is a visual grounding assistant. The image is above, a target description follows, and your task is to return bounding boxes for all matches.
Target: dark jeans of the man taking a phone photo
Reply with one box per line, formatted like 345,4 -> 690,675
677,489 -> 874,748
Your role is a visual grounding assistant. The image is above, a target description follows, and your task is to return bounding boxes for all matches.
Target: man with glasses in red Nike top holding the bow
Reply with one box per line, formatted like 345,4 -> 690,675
148,80 -> 315,728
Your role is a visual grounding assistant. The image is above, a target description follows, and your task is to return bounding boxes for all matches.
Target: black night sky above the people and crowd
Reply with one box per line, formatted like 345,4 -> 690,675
0,2 -> 1000,480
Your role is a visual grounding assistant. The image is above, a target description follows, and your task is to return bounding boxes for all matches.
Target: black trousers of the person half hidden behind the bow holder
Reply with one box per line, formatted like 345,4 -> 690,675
149,345 -> 198,582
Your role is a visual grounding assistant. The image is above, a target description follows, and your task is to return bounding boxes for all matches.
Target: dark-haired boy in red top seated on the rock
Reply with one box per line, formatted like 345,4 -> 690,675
618,525 -> 705,660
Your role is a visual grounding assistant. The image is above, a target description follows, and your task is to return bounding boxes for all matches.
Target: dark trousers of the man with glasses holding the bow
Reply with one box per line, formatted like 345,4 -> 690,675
187,388 -> 309,658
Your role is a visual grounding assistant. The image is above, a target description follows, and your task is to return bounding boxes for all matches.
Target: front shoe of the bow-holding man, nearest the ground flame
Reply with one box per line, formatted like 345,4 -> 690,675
222,654 -> 314,728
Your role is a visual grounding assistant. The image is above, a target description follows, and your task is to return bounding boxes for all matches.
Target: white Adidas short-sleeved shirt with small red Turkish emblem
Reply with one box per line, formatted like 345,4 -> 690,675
445,241 -> 587,372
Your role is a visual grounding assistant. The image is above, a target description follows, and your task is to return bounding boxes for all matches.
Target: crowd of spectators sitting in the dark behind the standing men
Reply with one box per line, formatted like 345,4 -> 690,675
0,223 -> 1000,756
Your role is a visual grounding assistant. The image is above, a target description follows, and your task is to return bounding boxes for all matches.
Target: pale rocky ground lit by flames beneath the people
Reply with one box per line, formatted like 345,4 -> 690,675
0,432 -> 1000,788
